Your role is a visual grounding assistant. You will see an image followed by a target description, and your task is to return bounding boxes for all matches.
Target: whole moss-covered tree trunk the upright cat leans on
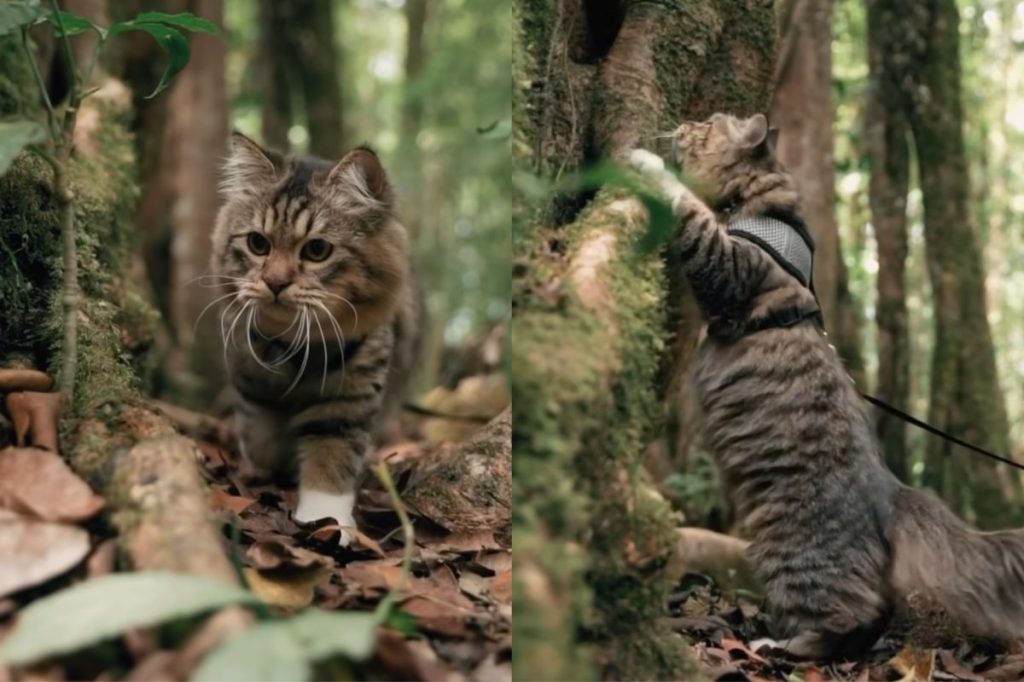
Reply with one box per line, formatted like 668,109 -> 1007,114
512,0 -> 774,679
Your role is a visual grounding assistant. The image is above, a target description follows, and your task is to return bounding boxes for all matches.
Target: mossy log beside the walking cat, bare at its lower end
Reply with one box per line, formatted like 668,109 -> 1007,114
0,40 -> 234,581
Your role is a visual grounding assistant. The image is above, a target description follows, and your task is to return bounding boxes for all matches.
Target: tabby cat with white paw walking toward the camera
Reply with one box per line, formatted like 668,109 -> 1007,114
212,134 -> 419,545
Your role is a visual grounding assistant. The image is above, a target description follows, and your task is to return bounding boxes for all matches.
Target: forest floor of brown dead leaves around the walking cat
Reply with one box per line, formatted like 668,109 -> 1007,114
0,385 -> 512,682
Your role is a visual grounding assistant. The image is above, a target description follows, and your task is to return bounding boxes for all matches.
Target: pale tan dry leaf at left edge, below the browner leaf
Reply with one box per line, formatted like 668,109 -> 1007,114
0,510 -> 89,597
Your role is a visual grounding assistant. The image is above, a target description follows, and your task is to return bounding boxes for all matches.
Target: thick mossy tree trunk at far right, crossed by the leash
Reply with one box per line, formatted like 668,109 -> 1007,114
868,0 -> 1020,525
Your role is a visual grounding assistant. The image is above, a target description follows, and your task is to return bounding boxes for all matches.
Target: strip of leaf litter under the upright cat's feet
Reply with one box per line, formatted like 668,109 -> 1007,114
669,573 -> 1024,682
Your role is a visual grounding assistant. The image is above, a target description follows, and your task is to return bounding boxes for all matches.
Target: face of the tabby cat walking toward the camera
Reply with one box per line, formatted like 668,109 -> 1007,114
213,135 -> 408,338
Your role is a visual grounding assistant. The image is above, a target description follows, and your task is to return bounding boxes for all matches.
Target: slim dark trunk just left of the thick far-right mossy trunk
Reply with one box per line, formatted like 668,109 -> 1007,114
865,3 -> 910,482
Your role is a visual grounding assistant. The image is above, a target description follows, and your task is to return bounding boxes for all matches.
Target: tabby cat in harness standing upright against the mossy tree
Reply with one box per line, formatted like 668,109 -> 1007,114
632,114 -> 1024,658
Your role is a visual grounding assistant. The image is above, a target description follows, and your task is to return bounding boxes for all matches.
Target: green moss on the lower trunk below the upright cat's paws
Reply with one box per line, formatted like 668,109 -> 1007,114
512,191 -> 691,679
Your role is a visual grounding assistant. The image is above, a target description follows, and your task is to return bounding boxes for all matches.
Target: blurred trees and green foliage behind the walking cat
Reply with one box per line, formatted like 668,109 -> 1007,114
123,0 -> 511,407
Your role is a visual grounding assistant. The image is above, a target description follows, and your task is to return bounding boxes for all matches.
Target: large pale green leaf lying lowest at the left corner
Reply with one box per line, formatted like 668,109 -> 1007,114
0,571 -> 259,666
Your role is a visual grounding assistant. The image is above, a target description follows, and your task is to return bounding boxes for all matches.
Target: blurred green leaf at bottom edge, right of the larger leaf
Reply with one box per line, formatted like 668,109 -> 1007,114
193,608 -> 379,682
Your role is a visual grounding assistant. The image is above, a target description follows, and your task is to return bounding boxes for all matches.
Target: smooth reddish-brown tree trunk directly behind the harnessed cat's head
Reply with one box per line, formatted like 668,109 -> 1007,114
769,0 -> 863,385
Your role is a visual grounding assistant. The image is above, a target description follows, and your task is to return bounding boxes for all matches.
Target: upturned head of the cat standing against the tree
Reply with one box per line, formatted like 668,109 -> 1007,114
673,114 -> 776,199
